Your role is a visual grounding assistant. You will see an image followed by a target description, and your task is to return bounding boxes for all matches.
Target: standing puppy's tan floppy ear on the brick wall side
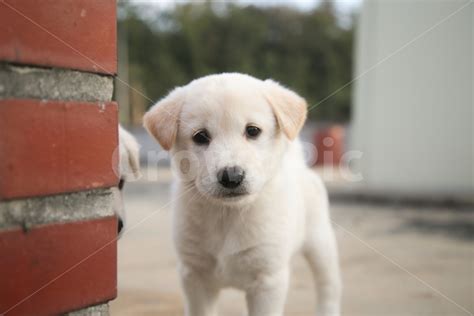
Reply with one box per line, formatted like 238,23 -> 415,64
143,88 -> 184,150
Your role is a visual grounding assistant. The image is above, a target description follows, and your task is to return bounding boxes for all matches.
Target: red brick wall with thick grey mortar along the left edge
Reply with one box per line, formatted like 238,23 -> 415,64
0,0 -> 118,315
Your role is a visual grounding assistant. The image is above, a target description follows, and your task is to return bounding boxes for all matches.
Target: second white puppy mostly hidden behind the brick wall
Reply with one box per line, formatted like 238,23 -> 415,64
112,125 -> 140,237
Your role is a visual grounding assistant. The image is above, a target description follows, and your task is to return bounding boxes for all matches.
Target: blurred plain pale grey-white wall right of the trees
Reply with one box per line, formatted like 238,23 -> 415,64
352,0 -> 474,199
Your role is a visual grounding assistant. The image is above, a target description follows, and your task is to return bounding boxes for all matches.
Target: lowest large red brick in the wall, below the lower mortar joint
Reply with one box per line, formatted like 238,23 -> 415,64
0,217 -> 117,315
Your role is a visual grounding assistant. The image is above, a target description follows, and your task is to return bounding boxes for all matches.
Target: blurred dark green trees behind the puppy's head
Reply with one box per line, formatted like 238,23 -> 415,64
119,0 -> 353,122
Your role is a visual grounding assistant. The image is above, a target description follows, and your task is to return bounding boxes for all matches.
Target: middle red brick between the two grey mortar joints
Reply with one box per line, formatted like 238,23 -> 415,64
0,99 -> 118,199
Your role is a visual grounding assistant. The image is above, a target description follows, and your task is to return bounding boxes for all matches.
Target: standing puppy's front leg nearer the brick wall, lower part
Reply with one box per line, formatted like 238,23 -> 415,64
180,267 -> 219,316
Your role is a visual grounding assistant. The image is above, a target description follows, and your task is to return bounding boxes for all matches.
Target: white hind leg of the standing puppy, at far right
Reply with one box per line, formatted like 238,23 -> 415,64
303,220 -> 342,316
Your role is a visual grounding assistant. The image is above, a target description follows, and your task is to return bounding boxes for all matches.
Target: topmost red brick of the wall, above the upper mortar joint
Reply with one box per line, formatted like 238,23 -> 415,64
0,0 -> 117,74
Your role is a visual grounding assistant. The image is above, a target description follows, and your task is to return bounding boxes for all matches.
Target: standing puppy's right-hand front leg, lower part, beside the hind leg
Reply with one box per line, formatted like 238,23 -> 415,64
246,268 -> 289,316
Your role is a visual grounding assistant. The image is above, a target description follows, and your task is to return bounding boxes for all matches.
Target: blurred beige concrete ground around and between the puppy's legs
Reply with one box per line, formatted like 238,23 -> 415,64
110,169 -> 474,316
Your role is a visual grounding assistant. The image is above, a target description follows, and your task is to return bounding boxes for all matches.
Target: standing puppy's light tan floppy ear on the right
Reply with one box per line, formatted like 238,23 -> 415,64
264,79 -> 307,140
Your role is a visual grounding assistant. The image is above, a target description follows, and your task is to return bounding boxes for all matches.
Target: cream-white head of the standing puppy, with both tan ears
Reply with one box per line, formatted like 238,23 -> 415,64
144,73 -> 306,203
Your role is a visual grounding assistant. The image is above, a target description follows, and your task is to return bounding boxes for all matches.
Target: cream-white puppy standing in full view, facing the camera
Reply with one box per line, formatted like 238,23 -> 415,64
144,73 -> 341,316
